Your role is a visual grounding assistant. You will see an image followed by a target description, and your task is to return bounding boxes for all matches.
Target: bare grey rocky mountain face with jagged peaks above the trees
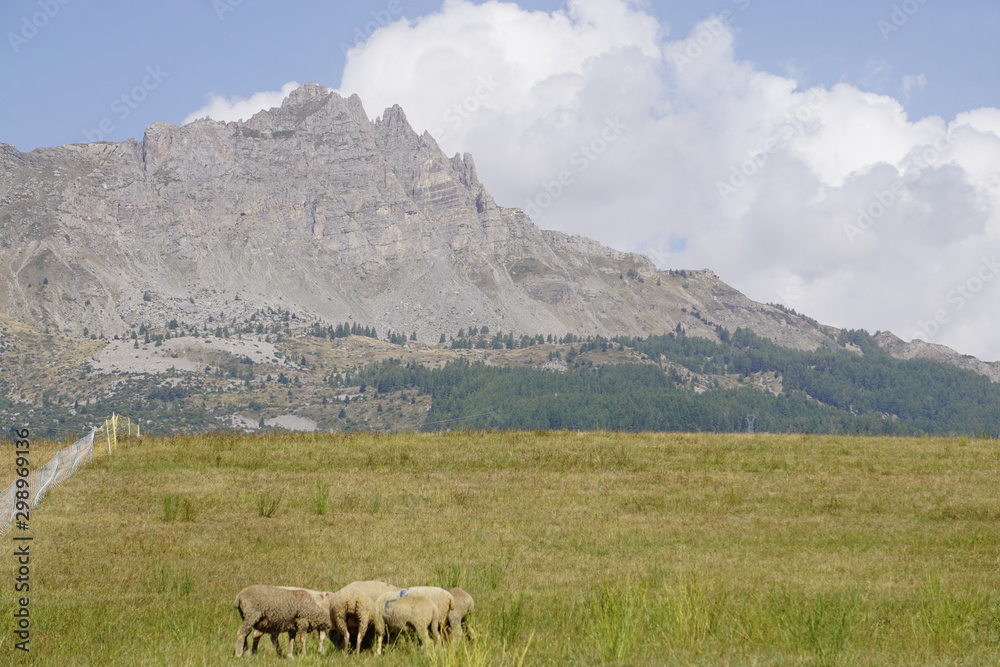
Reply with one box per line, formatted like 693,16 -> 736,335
0,84 -> 892,349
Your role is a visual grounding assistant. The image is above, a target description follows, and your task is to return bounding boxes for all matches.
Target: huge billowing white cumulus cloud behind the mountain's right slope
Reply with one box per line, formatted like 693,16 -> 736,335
182,0 -> 1000,360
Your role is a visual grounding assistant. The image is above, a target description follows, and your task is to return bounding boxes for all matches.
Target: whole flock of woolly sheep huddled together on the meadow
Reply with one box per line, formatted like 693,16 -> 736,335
233,581 -> 475,657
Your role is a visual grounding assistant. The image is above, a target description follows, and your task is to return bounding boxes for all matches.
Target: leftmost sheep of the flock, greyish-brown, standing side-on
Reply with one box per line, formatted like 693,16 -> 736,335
233,585 -> 333,658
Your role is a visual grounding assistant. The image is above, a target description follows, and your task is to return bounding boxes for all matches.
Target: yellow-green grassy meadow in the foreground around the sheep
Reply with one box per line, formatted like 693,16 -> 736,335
0,432 -> 1000,665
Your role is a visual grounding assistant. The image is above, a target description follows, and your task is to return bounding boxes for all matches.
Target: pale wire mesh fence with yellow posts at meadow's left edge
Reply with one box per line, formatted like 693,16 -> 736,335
0,415 -> 141,537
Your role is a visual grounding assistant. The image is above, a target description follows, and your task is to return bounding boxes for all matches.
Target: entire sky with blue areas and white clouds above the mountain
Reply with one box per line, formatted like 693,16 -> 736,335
0,0 -> 1000,360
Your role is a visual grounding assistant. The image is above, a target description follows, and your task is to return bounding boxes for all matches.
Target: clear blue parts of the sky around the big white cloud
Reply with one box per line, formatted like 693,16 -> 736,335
0,0 -> 1000,150
